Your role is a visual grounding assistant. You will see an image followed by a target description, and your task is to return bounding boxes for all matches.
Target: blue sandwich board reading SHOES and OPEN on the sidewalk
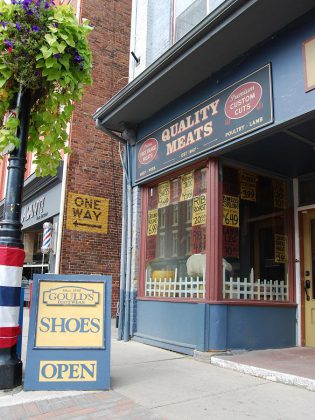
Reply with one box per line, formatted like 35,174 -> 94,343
24,274 -> 111,391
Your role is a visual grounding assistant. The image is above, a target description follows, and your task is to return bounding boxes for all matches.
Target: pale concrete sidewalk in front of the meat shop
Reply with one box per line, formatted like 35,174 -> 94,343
0,306 -> 315,420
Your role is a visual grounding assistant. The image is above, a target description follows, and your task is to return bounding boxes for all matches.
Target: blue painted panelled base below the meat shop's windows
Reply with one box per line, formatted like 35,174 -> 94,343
134,301 -> 296,354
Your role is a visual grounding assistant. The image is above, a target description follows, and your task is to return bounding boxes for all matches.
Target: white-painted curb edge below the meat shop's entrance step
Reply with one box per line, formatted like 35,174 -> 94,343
210,356 -> 315,391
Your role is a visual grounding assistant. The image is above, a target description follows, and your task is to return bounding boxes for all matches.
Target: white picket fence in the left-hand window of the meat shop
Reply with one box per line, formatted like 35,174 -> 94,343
145,275 -> 206,299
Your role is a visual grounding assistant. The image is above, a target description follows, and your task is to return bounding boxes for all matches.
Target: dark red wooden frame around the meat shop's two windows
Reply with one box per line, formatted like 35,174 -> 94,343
137,157 -> 297,307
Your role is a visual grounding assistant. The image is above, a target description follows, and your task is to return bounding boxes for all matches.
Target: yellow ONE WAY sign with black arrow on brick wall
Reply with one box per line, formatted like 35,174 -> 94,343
67,192 -> 109,233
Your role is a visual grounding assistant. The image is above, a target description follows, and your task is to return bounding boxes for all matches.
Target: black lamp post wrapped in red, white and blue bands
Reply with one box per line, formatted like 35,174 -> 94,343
0,88 -> 33,389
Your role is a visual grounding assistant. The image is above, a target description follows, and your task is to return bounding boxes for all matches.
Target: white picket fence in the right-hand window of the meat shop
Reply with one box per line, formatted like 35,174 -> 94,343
223,277 -> 288,301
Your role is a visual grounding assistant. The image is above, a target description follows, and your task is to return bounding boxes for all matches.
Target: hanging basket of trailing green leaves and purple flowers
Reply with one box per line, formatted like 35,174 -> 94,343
0,0 -> 92,176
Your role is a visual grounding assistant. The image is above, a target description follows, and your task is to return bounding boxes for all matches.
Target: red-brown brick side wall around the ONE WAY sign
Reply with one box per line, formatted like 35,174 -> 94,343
60,0 -> 131,314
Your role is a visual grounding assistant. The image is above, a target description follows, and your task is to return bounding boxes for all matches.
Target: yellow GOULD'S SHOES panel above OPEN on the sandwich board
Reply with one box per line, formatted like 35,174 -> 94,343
35,281 -> 105,348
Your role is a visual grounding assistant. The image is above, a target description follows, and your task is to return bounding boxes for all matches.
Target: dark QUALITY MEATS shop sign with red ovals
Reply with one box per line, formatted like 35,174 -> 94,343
136,64 -> 273,182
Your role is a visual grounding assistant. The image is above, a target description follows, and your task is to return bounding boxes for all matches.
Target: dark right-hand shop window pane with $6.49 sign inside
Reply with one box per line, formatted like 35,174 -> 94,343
222,167 -> 289,301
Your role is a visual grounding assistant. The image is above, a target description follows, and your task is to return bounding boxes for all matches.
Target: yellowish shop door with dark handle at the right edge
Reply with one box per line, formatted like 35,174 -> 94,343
303,210 -> 315,347
